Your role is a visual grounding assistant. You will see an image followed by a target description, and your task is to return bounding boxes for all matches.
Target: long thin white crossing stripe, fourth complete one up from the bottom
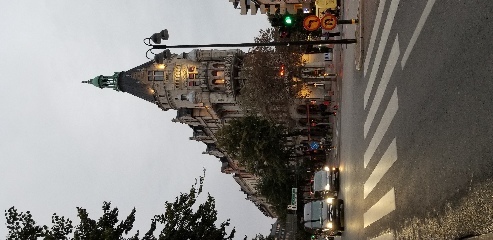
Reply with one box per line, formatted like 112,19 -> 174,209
364,35 -> 400,138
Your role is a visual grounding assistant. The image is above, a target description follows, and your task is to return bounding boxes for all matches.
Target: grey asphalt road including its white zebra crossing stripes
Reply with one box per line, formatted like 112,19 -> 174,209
339,0 -> 493,239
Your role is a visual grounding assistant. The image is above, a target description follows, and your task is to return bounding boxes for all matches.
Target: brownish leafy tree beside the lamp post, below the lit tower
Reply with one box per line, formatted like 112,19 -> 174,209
238,28 -> 305,121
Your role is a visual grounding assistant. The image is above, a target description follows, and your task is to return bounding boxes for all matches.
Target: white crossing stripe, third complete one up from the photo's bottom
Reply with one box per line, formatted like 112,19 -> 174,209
363,88 -> 399,168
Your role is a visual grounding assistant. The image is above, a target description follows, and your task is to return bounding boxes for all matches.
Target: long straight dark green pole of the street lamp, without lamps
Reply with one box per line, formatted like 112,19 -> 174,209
149,39 -> 356,49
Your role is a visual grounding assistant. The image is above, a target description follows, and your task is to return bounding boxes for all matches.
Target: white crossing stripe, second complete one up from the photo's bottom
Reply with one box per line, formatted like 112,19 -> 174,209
363,138 -> 397,198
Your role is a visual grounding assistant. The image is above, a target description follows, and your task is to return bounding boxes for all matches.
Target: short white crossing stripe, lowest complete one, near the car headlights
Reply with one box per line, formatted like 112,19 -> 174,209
363,188 -> 395,228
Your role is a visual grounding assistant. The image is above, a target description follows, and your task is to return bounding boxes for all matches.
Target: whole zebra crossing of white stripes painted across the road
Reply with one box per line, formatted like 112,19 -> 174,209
363,0 -> 435,239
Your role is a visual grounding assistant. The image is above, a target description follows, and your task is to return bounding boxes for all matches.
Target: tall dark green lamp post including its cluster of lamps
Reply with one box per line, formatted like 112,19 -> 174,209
144,29 -> 356,63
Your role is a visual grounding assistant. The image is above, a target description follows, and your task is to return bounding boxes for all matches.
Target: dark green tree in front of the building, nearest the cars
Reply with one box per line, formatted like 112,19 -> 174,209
216,116 -> 302,219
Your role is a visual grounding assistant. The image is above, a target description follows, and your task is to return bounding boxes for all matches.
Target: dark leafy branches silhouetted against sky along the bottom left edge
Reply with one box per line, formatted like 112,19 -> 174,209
5,171 -> 236,240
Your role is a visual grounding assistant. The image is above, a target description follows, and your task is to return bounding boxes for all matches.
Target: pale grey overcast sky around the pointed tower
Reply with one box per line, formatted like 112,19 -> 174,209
0,0 -> 275,239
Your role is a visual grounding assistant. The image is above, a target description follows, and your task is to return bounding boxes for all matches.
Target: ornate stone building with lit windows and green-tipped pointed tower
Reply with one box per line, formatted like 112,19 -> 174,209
83,49 -> 336,217
